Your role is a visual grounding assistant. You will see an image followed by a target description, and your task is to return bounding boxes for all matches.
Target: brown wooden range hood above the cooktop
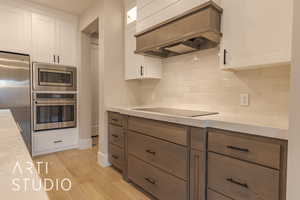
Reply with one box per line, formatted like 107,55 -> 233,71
135,1 -> 223,58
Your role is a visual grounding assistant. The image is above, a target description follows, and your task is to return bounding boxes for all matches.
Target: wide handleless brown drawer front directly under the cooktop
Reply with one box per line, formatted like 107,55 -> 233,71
128,117 -> 187,145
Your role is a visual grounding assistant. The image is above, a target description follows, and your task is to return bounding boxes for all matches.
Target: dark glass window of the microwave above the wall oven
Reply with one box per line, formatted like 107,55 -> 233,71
39,70 -> 72,86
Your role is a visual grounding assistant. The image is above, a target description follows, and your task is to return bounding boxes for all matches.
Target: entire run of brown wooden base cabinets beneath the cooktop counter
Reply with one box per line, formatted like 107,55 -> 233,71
108,112 -> 287,200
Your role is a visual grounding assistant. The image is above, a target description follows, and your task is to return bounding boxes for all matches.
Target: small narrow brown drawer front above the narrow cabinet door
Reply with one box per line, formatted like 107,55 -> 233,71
191,128 -> 207,151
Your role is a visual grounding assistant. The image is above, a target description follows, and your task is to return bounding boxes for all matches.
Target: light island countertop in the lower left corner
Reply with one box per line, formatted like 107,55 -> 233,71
0,110 -> 48,200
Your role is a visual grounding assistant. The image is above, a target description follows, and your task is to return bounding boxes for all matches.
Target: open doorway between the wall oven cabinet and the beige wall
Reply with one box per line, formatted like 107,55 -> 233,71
80,19 -> 99,146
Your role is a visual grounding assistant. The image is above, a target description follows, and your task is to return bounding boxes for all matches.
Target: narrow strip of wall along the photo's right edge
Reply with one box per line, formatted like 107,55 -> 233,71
287,0 -> 300,200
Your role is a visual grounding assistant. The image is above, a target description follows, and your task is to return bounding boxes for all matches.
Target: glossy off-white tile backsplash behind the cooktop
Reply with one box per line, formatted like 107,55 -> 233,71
140,49 -> 290,117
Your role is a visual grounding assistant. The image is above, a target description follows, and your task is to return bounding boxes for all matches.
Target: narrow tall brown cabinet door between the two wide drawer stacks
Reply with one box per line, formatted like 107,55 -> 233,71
190,150 -> 206,200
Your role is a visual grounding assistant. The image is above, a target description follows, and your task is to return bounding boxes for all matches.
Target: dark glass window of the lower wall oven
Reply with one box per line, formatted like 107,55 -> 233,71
36,105 -> 75,124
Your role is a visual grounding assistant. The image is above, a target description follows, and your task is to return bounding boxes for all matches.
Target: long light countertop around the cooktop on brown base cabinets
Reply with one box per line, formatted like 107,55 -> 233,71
107,107 -> 288,140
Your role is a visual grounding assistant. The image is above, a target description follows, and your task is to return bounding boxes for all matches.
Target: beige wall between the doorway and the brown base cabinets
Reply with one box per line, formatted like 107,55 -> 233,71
80,0 -> 138,166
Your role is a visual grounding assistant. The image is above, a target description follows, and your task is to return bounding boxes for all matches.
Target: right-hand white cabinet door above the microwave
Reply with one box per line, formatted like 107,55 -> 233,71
56,20 -> 77,66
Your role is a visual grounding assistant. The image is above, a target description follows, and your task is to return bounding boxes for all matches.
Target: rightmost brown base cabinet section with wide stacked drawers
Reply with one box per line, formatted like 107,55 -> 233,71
208,129 -> 287,200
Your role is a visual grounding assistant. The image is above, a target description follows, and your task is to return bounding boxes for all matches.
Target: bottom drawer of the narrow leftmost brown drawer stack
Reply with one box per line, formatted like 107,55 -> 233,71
109,144 -> 124,170
